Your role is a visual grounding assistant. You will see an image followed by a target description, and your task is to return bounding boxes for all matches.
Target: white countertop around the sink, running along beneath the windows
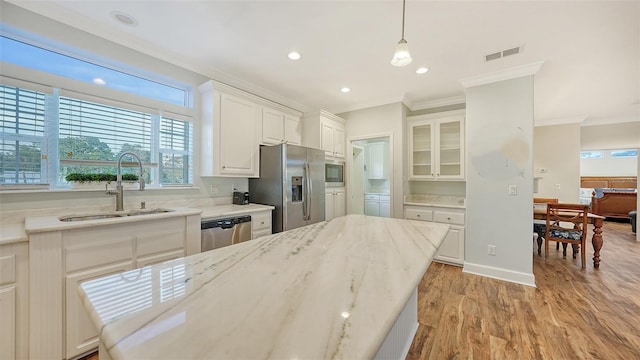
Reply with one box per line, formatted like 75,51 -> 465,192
0,198 -> 273,245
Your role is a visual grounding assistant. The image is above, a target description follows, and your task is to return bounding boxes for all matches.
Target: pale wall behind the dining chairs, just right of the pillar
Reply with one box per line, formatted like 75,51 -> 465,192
533,124 -> 580,203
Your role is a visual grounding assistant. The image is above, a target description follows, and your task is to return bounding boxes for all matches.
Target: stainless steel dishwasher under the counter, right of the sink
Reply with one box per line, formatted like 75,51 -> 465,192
200,215 -> 251,252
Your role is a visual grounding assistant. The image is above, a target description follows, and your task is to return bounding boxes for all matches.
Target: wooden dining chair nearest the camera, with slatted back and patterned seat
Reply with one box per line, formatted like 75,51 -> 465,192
544,203 -> 589,268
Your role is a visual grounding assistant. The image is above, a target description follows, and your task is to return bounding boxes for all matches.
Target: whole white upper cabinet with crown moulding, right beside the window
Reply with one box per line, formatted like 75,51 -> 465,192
199,81 -> 262,177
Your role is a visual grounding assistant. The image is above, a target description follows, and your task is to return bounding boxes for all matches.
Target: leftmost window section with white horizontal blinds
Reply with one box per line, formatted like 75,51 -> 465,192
0,85 -> 46,184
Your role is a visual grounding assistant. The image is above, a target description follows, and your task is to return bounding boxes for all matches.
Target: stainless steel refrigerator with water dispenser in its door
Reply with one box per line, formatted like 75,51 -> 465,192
249,144 -> 325,233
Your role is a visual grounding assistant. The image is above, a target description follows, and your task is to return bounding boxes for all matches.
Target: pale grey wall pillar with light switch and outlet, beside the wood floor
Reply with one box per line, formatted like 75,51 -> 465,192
464,75 -> 535,285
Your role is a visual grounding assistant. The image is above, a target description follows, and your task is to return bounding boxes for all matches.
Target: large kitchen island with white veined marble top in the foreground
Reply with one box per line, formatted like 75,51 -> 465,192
80,215 -> 449,360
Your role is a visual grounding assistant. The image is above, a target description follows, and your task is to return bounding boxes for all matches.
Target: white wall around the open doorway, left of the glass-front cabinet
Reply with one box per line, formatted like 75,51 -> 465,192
337,103 -> 406,218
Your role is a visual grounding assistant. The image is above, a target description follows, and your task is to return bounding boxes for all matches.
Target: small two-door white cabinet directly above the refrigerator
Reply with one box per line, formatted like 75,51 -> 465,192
261,107 -> 302,145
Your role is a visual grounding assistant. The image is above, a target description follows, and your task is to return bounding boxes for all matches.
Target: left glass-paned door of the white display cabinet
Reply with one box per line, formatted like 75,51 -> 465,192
409,120 -> 435,179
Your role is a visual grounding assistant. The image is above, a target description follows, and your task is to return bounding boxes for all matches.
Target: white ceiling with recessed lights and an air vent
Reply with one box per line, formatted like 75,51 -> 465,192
10,0 -> 640,125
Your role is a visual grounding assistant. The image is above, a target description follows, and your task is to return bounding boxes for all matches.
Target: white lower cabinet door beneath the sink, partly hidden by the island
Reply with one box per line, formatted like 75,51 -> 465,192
65,261 -> 133,359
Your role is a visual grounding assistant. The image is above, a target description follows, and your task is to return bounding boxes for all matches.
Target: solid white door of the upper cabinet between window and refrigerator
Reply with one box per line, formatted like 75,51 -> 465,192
218,94 -> 257,176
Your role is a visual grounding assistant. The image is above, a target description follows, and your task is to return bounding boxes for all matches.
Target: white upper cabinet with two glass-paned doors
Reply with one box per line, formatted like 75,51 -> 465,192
407,110 -> 465,180
